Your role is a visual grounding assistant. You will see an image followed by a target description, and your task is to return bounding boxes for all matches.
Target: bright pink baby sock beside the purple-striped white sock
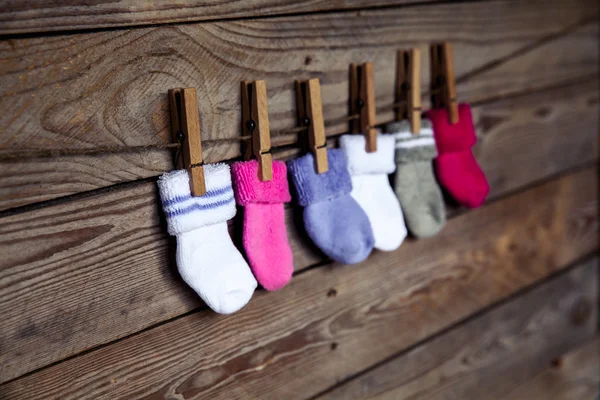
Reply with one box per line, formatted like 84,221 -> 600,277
232,160 -> 294,290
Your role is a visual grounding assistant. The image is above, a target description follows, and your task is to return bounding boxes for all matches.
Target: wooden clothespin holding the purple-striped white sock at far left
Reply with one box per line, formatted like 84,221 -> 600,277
169,88 -> 206,196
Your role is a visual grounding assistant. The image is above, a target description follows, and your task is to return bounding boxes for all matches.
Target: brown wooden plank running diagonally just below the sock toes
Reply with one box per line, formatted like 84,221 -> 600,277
0,168 -> 598,400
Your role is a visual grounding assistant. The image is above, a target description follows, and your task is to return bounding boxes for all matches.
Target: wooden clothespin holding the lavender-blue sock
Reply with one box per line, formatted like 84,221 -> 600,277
296,78 -> 329,174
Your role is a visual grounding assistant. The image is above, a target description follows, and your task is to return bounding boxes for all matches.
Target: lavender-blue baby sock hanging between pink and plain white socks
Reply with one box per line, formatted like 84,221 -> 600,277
288,149 -> 374,264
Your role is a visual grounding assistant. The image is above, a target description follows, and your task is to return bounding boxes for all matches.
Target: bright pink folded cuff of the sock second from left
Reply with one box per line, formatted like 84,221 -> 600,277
231,160 -> 291,206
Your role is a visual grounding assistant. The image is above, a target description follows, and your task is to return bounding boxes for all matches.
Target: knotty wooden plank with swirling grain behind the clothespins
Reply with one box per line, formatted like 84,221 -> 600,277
0,0 -> 598,209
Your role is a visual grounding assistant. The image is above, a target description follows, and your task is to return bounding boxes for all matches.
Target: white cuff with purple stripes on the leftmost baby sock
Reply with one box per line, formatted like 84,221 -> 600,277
158,163 -> 236,236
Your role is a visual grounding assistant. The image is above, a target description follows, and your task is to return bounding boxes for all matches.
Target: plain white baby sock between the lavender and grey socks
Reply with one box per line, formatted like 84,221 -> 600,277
340,134 -> 406,251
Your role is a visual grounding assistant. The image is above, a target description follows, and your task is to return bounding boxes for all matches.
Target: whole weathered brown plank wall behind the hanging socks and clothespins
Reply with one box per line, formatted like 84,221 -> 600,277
0,0 -> 600,400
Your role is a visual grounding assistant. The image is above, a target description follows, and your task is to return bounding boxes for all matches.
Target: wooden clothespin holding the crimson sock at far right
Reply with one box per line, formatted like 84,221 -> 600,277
429,42 -> 458,124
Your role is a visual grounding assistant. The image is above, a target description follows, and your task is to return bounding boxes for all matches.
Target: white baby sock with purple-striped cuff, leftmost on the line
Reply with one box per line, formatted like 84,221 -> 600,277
158,164 -> 256,314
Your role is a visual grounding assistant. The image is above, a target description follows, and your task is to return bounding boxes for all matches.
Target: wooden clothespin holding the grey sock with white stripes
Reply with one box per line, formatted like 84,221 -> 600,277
396,49 -> 421,135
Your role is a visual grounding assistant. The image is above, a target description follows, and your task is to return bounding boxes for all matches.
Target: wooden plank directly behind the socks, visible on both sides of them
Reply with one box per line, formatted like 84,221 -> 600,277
0,77 -> 598,381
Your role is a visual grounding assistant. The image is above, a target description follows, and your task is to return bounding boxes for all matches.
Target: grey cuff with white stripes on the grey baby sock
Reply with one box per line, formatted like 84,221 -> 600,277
384,119 -> 437,164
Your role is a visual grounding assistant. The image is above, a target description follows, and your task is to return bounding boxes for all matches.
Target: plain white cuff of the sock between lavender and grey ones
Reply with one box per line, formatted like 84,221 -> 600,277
340,134 -> 396,175
